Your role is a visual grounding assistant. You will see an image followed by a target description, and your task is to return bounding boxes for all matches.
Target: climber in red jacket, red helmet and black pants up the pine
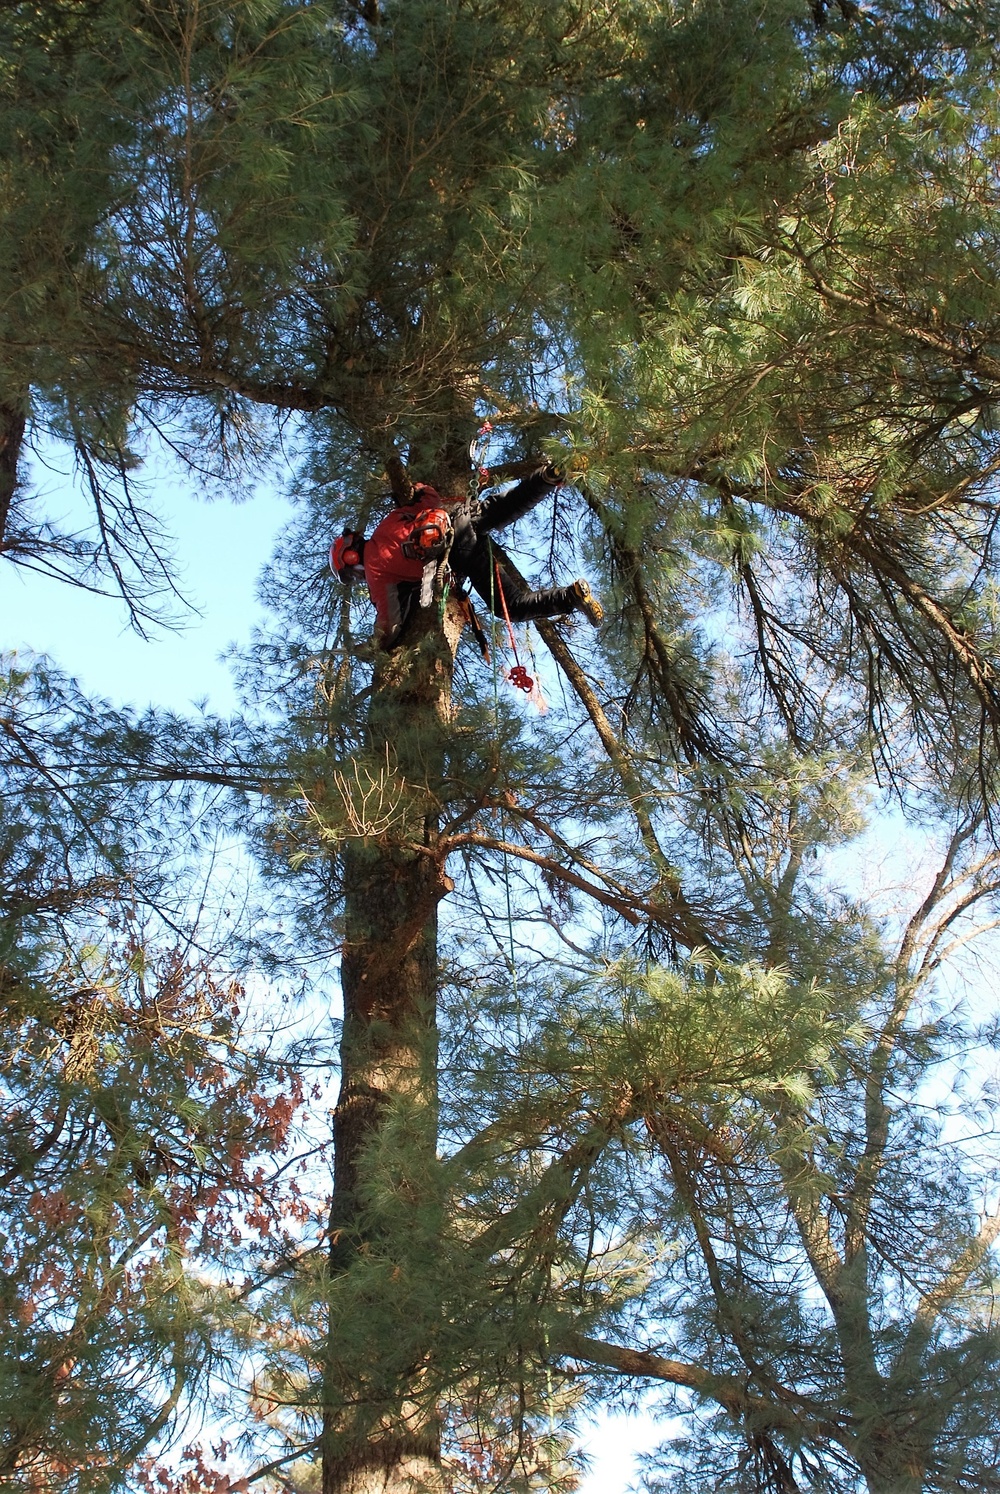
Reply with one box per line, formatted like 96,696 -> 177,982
330,466 -> 604,648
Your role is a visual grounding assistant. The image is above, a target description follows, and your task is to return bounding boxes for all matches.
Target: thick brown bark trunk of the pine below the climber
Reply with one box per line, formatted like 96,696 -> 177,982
323,607 -> 460,1494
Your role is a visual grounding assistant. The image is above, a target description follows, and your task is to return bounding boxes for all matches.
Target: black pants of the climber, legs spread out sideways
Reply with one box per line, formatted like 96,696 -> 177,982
450,472 -> 578,623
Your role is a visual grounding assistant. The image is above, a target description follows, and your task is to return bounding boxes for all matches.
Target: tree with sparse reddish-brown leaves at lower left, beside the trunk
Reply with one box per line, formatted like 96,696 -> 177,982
0,665 -> 324,1490
